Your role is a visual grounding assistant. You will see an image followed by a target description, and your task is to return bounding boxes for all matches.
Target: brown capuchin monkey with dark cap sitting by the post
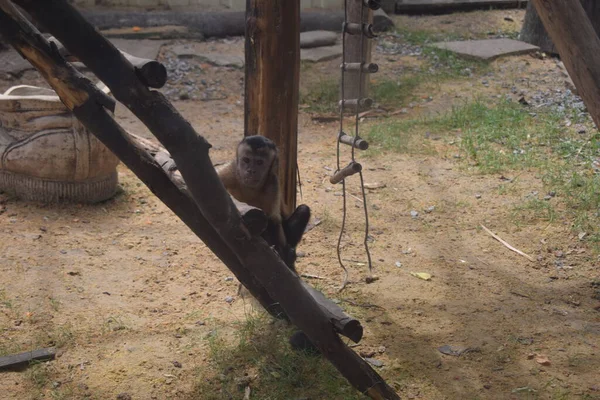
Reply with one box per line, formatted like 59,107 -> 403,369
217,135 -> 310,272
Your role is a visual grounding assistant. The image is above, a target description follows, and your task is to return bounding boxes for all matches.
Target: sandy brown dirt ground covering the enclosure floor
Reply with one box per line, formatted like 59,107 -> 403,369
0,10 -> 600,400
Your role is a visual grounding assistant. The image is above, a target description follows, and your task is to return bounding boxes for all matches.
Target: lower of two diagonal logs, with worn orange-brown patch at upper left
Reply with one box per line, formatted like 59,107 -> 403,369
0,2 -> 285,317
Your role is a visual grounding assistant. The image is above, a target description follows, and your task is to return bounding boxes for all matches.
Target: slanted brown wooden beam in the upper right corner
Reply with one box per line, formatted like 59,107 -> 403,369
531,0 -> 600,128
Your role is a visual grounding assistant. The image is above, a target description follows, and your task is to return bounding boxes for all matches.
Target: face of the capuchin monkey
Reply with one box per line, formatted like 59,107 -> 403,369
237,144 -> 275,189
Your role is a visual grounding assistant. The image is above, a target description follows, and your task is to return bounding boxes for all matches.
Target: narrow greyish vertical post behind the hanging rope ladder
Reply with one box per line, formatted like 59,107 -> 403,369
340,0 -> 373,106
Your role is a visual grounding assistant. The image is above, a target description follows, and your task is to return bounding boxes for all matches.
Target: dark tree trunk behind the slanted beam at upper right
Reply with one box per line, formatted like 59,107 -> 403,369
520,0 -> 600,54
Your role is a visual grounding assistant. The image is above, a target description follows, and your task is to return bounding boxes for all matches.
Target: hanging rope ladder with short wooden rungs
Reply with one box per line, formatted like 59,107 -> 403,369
330,0 -> 380,291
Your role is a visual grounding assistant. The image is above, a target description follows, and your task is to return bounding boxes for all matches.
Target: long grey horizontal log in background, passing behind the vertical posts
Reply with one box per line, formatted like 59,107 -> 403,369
81,9 -> 394,37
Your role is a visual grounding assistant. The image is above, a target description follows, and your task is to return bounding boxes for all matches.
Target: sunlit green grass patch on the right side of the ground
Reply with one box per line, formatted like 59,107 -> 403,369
365,100 -> 600,242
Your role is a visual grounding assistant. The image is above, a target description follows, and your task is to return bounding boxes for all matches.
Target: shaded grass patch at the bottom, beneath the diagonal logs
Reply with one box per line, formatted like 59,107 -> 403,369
190,315 -> 364,400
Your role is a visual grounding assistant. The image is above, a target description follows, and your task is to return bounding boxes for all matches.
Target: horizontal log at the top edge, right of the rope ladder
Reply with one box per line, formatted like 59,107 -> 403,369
395,0 -> 528,14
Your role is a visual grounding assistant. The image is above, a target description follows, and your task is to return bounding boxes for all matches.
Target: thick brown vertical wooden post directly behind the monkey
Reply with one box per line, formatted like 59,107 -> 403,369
244,0 -> 300,215
